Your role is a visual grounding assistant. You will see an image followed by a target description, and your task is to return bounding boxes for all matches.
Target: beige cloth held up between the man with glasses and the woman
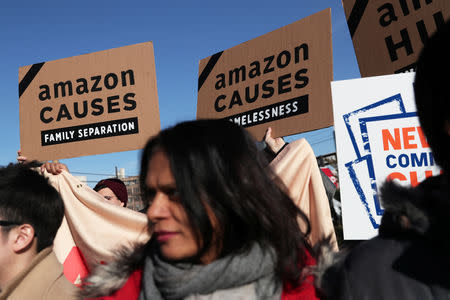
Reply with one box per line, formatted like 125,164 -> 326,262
45,171 -> 150,272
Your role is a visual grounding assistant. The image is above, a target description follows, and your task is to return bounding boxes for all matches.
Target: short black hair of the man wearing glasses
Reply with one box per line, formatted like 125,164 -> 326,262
0,164 -> 64,252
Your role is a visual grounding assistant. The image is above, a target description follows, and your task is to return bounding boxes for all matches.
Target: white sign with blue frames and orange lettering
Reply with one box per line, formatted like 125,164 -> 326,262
331,73 -> 440,240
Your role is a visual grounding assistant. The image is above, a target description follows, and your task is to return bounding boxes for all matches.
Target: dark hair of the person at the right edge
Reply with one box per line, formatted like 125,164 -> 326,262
414,21 -> 450,172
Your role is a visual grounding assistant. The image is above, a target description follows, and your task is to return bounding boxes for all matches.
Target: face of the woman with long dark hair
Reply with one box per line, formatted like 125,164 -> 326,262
145,151 -> 216,263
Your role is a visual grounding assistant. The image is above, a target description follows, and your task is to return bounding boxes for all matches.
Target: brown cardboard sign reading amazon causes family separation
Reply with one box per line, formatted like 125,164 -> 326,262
19,42 -> 160,160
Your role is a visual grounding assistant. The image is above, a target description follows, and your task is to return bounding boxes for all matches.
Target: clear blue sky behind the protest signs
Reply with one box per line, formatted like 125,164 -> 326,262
0,0 -> 360,181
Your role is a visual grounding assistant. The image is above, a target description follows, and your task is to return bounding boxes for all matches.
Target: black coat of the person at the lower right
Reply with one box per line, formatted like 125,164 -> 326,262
320,176 -> 450,300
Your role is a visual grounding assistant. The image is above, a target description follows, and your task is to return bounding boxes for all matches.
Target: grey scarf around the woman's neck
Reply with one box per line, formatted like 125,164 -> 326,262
139,244 -> 281,300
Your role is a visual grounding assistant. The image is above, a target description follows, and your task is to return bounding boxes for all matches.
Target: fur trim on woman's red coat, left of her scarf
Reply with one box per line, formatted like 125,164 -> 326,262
78,245 -> 147,299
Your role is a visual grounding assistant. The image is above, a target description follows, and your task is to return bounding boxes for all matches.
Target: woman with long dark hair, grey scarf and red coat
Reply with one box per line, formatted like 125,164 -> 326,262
83,120 -> 317,299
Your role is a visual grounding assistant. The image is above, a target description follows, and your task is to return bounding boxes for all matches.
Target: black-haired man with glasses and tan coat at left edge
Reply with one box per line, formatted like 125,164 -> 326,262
0,164 -> 76,300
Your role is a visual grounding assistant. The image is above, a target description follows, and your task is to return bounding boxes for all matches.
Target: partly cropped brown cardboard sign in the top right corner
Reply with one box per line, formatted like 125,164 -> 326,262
343,0 -> 450,77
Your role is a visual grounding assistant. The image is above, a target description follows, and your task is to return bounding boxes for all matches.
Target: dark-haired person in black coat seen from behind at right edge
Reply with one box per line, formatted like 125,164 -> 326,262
318,21 -> 450,300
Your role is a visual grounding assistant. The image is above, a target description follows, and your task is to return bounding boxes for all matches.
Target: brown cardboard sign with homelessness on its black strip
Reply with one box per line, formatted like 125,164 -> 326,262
197,9 -> 333,139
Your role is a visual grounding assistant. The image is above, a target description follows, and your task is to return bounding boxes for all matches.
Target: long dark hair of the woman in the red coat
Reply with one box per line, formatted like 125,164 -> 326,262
140,120 -> 311,283
